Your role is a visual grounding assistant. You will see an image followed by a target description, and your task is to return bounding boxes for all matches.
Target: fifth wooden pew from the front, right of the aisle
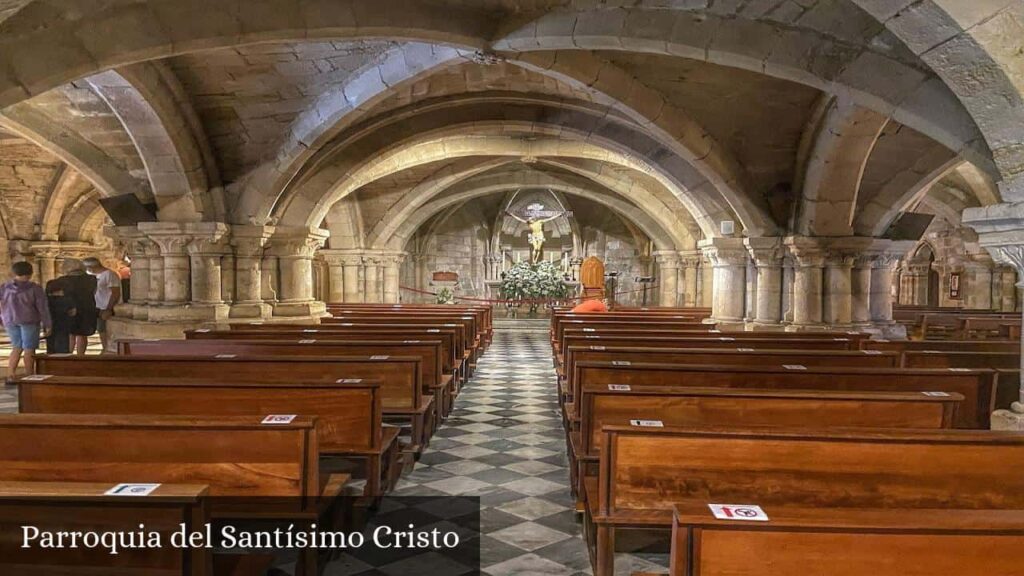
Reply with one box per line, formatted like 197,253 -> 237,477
564,342 -> 900,402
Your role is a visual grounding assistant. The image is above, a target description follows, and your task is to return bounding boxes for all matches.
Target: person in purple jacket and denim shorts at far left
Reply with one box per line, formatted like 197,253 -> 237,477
0,262 -> 52,384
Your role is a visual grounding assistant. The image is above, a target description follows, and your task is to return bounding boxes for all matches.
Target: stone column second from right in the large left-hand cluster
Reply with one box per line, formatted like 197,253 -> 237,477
231,225 -> 274,318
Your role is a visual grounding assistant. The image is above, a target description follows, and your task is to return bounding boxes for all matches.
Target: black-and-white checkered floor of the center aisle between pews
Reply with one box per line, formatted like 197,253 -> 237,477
395,321 -> 592,576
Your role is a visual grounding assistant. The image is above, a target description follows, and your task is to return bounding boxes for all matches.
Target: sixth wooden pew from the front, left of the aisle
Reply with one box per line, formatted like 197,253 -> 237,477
190,326 -> 460,385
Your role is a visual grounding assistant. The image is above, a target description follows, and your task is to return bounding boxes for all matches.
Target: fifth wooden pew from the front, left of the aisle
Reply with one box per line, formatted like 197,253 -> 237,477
118,332 -> 456,423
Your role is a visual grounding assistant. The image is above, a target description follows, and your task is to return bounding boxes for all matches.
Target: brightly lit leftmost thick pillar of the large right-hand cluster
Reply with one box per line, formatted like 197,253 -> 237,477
699,238 -> 748,329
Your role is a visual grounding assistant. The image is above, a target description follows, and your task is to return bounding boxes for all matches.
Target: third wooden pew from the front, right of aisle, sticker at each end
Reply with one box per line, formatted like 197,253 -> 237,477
569,384 -> 964,494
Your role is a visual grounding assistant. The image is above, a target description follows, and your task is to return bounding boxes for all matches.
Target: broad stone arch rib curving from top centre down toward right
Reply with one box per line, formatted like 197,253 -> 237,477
494,6 -> 990,172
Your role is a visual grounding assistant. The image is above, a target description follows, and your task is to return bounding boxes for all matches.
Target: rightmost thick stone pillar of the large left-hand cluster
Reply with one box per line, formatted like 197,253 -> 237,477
269,228 -> 329,317
